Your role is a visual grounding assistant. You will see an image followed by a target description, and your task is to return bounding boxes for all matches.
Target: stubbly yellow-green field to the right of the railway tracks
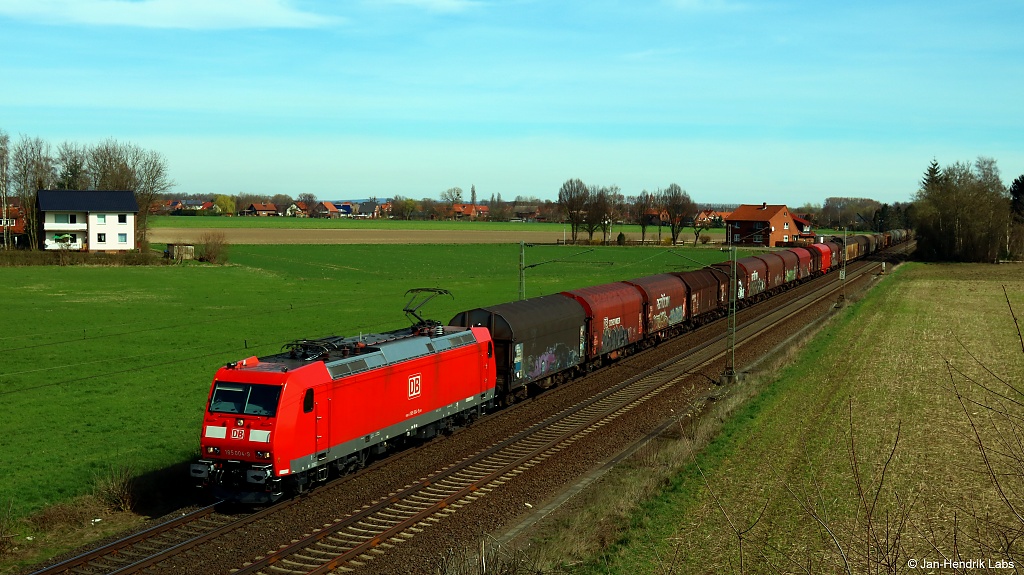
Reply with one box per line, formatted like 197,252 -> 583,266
546,264 -> 1024,574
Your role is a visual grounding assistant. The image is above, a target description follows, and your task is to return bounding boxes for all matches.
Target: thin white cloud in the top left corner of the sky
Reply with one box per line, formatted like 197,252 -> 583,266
0,0 -> 338,30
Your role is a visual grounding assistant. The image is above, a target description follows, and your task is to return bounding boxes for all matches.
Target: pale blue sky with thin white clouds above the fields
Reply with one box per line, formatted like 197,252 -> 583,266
0,0 -> 1024,206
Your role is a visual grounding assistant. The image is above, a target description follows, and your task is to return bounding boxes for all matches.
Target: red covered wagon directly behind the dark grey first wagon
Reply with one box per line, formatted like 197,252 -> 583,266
561,281 -> 643,359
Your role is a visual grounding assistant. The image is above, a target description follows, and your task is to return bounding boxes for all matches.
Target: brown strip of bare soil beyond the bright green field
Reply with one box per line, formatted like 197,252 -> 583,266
150,228 -> 577,244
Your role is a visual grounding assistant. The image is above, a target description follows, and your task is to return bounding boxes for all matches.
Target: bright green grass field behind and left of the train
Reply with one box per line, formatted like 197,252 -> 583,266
0,245 -> 737,517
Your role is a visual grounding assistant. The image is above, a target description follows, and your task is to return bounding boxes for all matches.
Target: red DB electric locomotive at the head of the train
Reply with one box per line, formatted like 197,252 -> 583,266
191,325 -> 495,503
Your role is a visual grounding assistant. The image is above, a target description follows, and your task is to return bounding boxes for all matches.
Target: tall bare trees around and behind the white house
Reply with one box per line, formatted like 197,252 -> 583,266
0,130 -> 174,247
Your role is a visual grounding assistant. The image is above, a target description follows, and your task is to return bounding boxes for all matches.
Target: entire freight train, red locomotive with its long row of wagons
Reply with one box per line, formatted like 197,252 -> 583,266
190,230 -> 910,503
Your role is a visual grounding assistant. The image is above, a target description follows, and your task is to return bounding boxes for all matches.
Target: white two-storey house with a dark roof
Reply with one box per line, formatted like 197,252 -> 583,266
38,189 -> 138,252
